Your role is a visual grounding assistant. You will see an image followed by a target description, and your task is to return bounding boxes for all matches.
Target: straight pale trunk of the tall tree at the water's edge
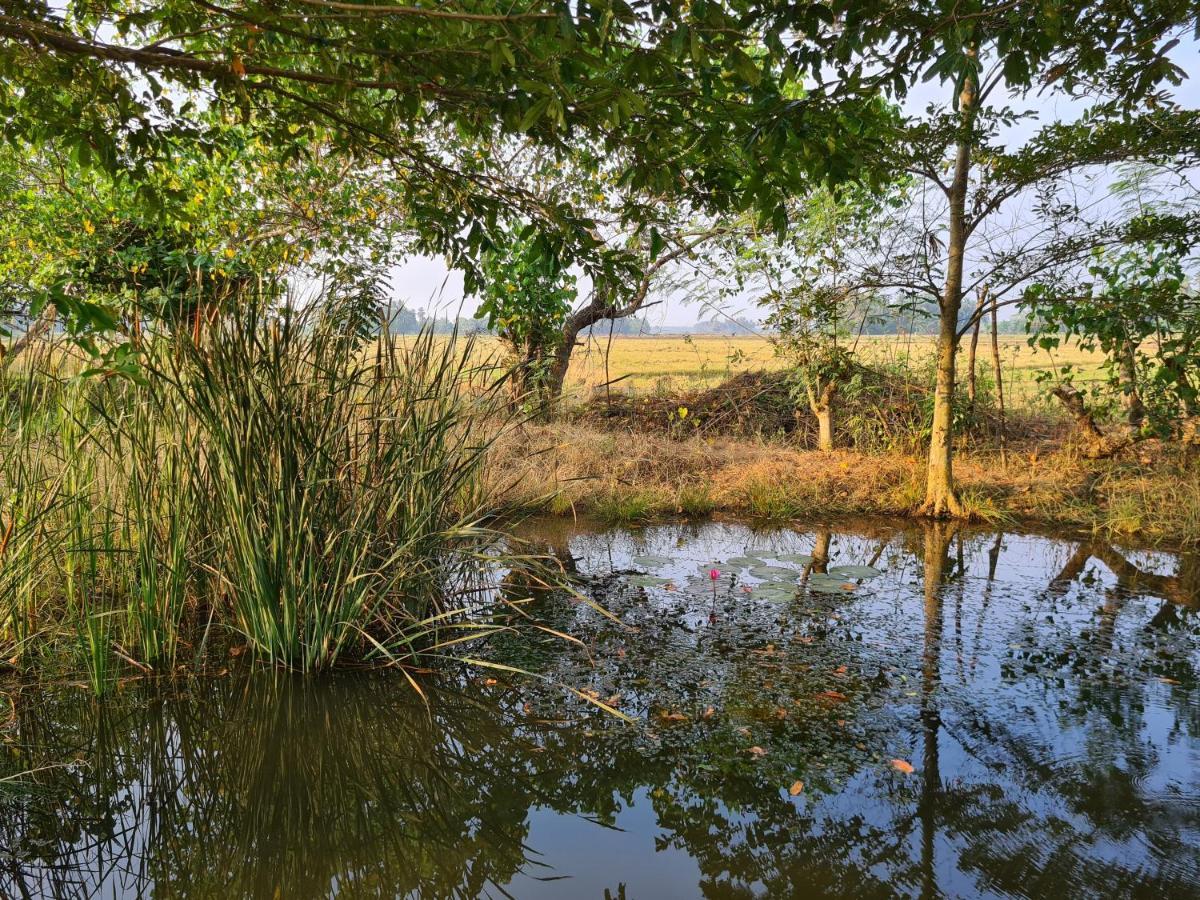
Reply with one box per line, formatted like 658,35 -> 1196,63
919,77 -> 974,517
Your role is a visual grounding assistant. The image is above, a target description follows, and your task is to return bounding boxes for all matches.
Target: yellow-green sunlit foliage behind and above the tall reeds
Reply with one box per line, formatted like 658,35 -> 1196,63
0,126 -> 408,362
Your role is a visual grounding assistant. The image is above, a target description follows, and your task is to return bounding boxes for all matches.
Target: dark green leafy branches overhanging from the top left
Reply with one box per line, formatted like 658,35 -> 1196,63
0,0 -> 876,345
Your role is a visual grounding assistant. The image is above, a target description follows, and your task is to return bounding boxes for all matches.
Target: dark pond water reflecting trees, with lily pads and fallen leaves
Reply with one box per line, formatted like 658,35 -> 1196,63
0,522 -> 1200,900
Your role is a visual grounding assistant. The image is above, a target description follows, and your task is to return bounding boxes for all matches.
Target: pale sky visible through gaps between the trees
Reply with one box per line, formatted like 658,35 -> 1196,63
389,37 -> 1200,326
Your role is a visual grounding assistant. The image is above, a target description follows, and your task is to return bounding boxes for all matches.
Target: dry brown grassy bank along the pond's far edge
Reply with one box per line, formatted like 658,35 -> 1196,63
492,422 -> 1200,546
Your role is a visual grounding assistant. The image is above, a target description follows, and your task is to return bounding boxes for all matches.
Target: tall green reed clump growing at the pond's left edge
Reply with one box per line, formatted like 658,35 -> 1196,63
0,305 -> 530,691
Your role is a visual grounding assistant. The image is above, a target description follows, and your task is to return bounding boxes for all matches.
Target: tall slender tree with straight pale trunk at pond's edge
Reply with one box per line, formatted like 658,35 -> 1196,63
748,0 -> 1200,516
